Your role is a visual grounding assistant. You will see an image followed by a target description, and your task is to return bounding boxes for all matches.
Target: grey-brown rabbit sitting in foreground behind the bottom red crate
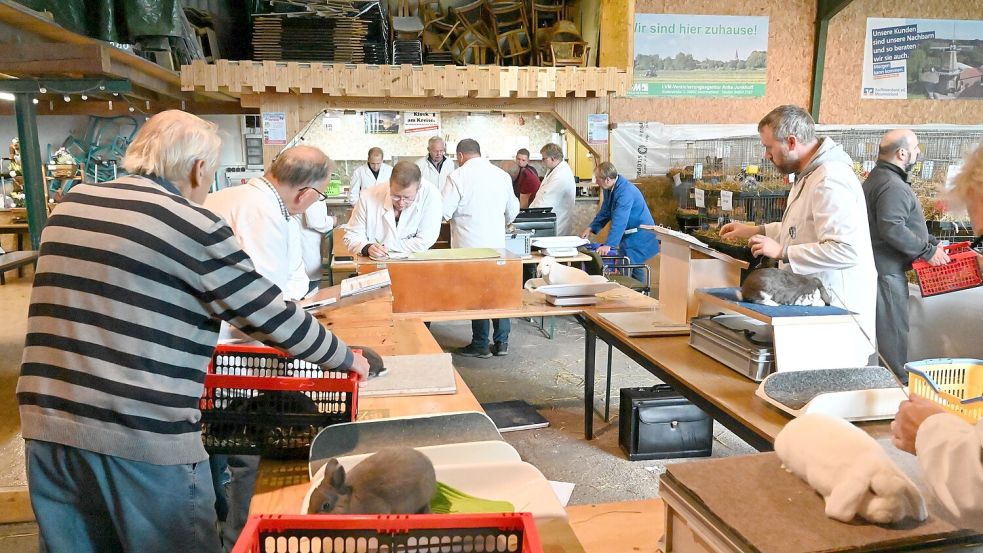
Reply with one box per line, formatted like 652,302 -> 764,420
307,447 -> 437,515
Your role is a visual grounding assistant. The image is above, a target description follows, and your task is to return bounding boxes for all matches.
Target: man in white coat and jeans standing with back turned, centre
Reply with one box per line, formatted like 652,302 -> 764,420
442,138 -> 519,359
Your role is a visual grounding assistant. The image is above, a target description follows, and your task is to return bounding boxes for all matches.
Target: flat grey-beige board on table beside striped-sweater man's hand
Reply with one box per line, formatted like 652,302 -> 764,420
358,353 -> 457,397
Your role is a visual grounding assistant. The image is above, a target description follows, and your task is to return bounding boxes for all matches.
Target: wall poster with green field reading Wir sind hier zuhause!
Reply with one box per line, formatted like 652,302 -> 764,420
628,13 -> 768,98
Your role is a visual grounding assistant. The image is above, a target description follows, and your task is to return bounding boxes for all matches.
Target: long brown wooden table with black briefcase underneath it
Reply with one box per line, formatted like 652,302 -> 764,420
578,311 -> 890,451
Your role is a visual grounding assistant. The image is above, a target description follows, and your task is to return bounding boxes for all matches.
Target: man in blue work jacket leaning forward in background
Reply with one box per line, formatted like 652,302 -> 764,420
580,161 -> 659,282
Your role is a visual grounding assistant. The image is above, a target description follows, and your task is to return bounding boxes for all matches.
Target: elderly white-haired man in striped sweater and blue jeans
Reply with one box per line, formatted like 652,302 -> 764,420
17,111 -> 368,553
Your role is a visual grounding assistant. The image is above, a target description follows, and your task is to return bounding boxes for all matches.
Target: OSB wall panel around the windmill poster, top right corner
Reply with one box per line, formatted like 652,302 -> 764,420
820,0 -> 983,125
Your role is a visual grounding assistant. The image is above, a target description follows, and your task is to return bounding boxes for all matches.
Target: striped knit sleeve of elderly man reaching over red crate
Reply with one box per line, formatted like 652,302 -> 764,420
198,220 -> 354,370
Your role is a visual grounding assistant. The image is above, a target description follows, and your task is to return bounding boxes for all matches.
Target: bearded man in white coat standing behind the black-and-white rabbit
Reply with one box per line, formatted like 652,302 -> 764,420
720,105 -> 877,366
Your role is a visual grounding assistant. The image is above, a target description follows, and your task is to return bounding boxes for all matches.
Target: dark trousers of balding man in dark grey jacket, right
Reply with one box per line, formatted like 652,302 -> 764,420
877,274 -> 908,383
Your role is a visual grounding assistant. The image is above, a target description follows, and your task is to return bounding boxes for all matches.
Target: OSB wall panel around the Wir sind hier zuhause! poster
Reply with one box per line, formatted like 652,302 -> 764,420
611,0 -> 820,124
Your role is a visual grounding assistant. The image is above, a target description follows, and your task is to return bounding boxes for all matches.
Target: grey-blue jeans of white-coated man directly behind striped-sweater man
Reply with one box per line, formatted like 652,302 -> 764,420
208,455 -> 260,553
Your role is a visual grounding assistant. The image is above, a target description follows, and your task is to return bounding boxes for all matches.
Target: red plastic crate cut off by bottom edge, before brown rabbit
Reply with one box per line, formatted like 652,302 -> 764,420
232,513 -> 543,553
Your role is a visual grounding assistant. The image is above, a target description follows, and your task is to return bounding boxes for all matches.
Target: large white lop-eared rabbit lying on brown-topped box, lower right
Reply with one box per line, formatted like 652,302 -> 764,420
775,414 -> 928,524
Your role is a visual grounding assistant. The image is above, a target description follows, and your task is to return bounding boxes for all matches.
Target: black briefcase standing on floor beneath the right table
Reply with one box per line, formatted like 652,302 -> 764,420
618,384 -> 713,461
